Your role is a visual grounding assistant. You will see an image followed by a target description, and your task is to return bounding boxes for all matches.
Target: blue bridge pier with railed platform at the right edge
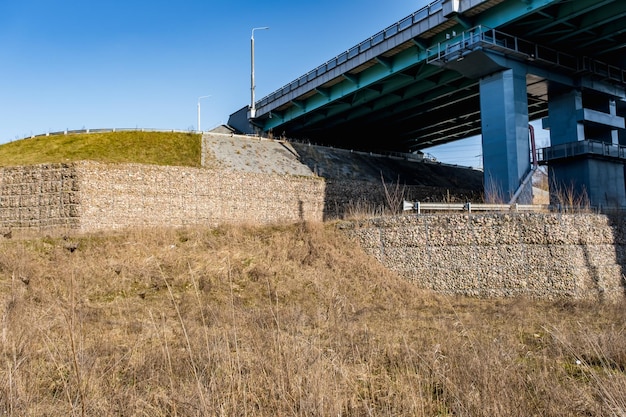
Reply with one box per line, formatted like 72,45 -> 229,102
544,82 -> 626,208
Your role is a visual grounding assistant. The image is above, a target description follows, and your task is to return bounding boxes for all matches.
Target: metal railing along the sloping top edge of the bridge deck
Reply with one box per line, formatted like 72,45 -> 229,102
256,0 -> 444,109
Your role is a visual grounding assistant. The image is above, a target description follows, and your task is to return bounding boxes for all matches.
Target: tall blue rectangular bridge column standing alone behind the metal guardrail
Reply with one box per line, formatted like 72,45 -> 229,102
480,68 -> 532,204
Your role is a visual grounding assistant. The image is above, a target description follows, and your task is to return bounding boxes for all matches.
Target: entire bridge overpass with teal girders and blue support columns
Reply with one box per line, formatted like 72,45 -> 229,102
229,0 -> 626,206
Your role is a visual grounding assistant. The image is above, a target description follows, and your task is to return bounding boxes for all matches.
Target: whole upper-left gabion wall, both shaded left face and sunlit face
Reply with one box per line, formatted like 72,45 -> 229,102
0,162 -> 324,231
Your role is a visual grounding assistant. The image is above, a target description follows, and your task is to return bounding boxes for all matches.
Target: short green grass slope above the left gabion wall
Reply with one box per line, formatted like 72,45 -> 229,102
0,131 -> 202,167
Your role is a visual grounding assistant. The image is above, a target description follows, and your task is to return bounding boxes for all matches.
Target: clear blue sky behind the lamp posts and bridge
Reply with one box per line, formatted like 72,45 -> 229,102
0,0 -> 544,166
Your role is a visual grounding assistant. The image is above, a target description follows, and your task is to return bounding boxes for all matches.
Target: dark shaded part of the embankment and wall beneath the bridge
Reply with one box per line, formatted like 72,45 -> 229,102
291,142 -> 483,220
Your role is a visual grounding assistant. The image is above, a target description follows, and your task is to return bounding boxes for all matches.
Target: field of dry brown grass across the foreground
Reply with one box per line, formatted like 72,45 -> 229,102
0,224 -> 626,417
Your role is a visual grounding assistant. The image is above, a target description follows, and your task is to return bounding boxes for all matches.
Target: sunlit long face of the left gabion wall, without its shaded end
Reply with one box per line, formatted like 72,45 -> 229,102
76,162 -> 324,230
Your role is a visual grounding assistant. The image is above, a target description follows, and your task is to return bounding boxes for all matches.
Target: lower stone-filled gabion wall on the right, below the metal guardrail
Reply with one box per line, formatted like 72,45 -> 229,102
342,213 -> 626,299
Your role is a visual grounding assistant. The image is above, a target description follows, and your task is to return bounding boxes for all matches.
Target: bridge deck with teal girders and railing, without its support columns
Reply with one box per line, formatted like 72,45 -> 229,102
232,0 -> 626,151
